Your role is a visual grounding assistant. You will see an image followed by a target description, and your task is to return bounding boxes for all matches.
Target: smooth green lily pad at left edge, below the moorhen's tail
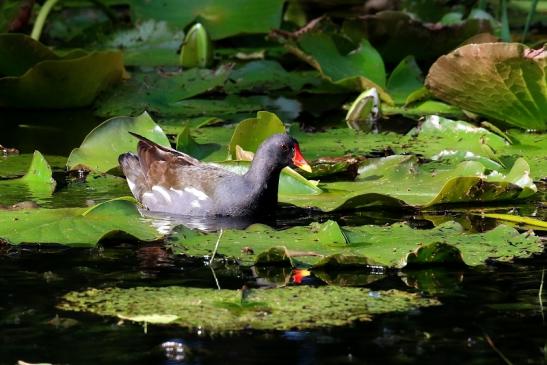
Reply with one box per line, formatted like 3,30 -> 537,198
0,198 -> 161,247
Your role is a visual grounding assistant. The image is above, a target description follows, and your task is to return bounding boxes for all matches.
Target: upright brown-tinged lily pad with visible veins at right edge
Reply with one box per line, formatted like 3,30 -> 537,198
426,43 -> 547,130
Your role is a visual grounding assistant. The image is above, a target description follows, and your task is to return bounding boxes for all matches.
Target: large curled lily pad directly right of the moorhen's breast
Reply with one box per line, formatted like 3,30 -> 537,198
288,155 -> 537,211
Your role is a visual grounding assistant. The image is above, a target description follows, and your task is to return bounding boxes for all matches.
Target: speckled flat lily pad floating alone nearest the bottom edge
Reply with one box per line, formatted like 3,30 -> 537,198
58,286 -> 439,333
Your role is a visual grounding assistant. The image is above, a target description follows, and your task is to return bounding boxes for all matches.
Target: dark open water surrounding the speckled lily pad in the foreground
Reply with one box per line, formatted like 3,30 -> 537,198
0,245 -> 547,364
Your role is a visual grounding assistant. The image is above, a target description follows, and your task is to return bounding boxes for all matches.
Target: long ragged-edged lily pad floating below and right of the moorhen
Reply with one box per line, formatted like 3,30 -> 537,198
168,221 -> 543,268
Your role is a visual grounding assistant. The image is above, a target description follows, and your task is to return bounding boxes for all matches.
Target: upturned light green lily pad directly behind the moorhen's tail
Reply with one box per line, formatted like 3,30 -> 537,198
67,112 -> 170,172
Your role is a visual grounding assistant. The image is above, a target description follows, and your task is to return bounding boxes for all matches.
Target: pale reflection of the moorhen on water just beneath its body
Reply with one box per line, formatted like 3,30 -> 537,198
137,209 -> 276,234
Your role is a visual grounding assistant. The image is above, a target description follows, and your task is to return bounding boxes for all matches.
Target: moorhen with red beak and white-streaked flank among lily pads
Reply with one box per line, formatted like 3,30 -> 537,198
118,133 -> 311,216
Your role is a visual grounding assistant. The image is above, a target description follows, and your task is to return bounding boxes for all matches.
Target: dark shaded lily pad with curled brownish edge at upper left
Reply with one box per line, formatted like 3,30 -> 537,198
0,34 -> 125,109
